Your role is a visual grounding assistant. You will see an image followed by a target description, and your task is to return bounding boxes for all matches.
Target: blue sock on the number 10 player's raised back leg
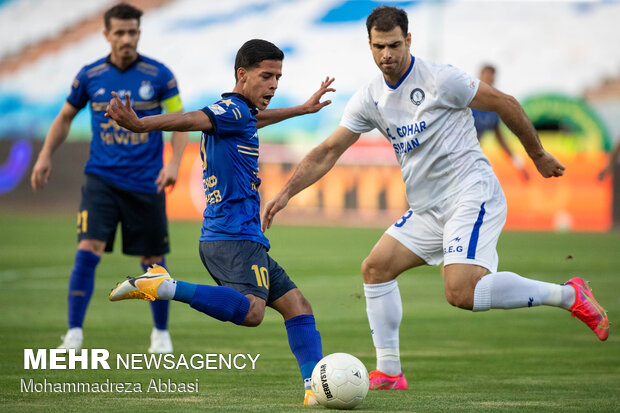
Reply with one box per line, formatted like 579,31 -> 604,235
186,281 -> 250,325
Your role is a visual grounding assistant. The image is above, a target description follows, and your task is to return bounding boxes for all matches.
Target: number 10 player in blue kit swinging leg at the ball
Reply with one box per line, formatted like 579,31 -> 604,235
107,39 -> 333,404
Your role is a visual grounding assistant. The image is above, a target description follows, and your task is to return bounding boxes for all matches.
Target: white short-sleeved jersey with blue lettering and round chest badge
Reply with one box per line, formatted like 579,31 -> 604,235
340,56 -> 493,213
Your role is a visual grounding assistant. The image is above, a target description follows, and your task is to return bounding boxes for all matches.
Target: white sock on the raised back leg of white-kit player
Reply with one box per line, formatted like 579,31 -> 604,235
473,271 -> 575,311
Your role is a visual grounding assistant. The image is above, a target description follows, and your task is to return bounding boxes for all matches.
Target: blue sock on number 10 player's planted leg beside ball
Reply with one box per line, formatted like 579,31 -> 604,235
284,314 -> 323,382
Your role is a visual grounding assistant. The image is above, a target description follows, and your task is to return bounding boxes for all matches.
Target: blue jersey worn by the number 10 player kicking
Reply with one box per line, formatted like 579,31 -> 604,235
200,93 -> 269,249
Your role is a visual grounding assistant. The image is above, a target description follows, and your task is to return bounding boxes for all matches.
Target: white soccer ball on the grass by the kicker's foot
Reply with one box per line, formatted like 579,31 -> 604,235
312,353 -> 368,409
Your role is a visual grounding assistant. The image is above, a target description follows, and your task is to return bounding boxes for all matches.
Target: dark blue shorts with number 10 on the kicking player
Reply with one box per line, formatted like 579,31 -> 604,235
199,240 -> 297,305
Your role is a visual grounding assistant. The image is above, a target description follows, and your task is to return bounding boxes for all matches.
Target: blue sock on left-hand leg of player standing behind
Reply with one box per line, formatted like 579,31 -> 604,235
67,250 -> 101,328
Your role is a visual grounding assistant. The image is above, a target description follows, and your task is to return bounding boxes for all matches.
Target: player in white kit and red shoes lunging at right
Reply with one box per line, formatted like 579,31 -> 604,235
262,6 -> 609,390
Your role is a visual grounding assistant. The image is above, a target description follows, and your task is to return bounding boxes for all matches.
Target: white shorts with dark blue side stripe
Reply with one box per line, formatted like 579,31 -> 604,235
385,176 -> 506,272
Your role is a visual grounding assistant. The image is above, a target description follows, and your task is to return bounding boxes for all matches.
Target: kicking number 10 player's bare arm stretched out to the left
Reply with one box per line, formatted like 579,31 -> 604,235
105,92 -> 213,133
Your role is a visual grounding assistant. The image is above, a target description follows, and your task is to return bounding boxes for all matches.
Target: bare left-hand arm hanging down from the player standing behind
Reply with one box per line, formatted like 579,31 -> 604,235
30,102 -> 78,191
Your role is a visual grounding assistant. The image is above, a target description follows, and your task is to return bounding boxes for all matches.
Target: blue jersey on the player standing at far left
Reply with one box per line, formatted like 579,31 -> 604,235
67,55 -> 179,193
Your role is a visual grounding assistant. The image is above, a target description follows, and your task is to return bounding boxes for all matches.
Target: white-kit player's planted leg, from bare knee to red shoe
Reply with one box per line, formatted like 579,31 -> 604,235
362,234 -> 425,390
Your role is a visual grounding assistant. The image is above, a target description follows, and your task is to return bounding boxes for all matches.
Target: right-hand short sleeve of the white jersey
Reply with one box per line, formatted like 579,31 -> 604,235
437,65 -> 480,109
